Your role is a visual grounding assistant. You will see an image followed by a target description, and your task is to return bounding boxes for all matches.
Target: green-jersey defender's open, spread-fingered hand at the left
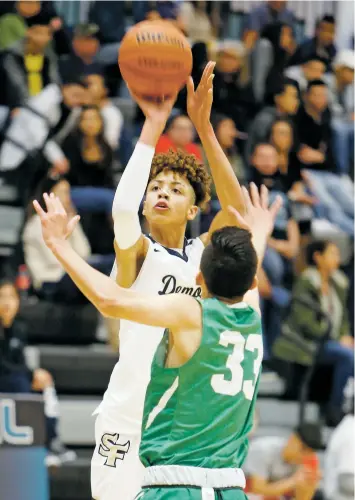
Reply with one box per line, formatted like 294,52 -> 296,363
33,193 -> 80,250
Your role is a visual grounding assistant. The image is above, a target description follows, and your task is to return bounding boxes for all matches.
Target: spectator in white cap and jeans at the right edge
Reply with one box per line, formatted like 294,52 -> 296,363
326,50 -> 355,174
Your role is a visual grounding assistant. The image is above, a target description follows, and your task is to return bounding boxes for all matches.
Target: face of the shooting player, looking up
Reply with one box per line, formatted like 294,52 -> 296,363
143,170 -> 198,226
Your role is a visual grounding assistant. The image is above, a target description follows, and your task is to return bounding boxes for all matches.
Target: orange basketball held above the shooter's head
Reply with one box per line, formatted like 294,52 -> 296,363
118,20 -> 192,97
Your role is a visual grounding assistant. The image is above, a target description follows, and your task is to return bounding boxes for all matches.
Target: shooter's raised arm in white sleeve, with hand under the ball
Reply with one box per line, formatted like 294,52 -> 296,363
112,93 -> 176,278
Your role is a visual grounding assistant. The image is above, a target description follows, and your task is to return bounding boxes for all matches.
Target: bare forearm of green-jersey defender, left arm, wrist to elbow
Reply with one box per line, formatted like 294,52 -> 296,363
52,241 -> 122,314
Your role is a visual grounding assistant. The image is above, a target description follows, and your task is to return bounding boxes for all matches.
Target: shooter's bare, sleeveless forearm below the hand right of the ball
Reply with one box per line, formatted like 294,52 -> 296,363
199,125 -> 245,215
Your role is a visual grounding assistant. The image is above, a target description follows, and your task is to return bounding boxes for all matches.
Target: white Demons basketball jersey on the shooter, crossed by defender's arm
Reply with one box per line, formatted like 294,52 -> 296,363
95,237 -> 204,434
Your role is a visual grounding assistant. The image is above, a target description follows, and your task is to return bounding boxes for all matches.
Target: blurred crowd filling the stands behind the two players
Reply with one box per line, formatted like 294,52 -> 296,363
0,0 -> 355,500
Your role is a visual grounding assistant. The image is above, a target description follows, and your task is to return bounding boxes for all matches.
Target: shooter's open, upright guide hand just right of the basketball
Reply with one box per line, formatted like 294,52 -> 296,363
187,61 -> 216,134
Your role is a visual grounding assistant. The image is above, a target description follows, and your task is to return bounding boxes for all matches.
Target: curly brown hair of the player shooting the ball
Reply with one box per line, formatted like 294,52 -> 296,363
149,150 -> 211,208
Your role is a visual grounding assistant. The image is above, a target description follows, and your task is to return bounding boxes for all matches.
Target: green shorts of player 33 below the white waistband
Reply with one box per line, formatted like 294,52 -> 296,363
135,486 -> 248,500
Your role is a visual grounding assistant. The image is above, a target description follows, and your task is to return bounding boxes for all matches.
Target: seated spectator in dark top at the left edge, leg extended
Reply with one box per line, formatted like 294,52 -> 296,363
0,281 -> 76,466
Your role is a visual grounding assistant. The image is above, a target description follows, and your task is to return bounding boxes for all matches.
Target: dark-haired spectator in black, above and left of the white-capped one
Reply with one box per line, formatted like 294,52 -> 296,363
289,14 -> 336,71
